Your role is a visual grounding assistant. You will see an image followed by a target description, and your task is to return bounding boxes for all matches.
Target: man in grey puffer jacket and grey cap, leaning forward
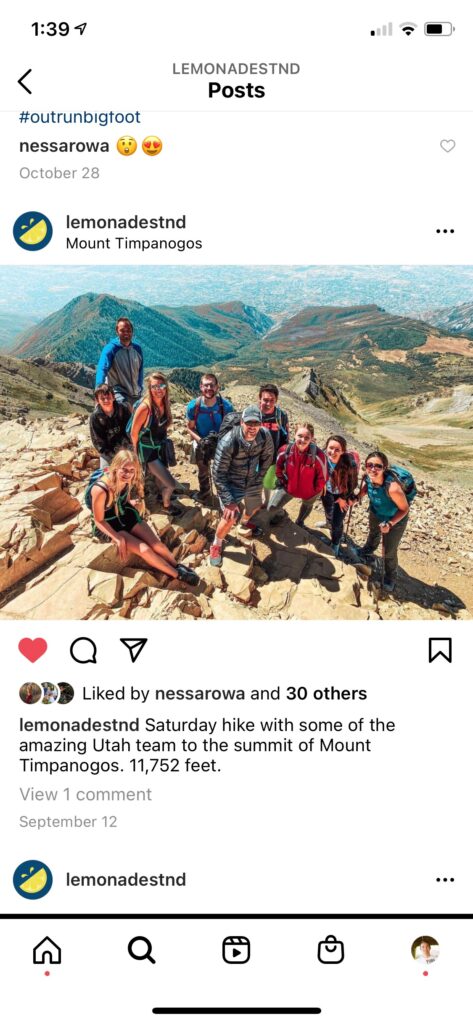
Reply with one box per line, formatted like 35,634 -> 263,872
210,406 -> 273,565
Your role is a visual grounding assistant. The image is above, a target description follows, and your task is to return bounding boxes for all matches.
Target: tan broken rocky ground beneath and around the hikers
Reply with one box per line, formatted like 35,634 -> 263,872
0,388 -> 473,620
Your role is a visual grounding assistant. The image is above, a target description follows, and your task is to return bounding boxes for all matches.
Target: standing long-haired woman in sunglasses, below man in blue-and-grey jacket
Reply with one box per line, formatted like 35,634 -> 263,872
129,371 -> 182,515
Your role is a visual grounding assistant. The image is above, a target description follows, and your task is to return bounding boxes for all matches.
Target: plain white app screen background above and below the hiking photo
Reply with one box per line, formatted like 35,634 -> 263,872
0,2 -> 472,1024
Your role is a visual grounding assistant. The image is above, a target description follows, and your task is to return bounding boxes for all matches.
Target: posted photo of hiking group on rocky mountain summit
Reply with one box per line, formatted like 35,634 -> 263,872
0,267 -> 473,621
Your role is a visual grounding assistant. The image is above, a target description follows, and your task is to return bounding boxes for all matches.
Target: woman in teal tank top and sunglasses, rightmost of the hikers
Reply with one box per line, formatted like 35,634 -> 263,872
356,452 -> 409,593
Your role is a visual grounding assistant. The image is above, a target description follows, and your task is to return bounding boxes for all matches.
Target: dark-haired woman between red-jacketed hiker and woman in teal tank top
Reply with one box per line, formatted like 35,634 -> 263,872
316,434 -> 359,558
